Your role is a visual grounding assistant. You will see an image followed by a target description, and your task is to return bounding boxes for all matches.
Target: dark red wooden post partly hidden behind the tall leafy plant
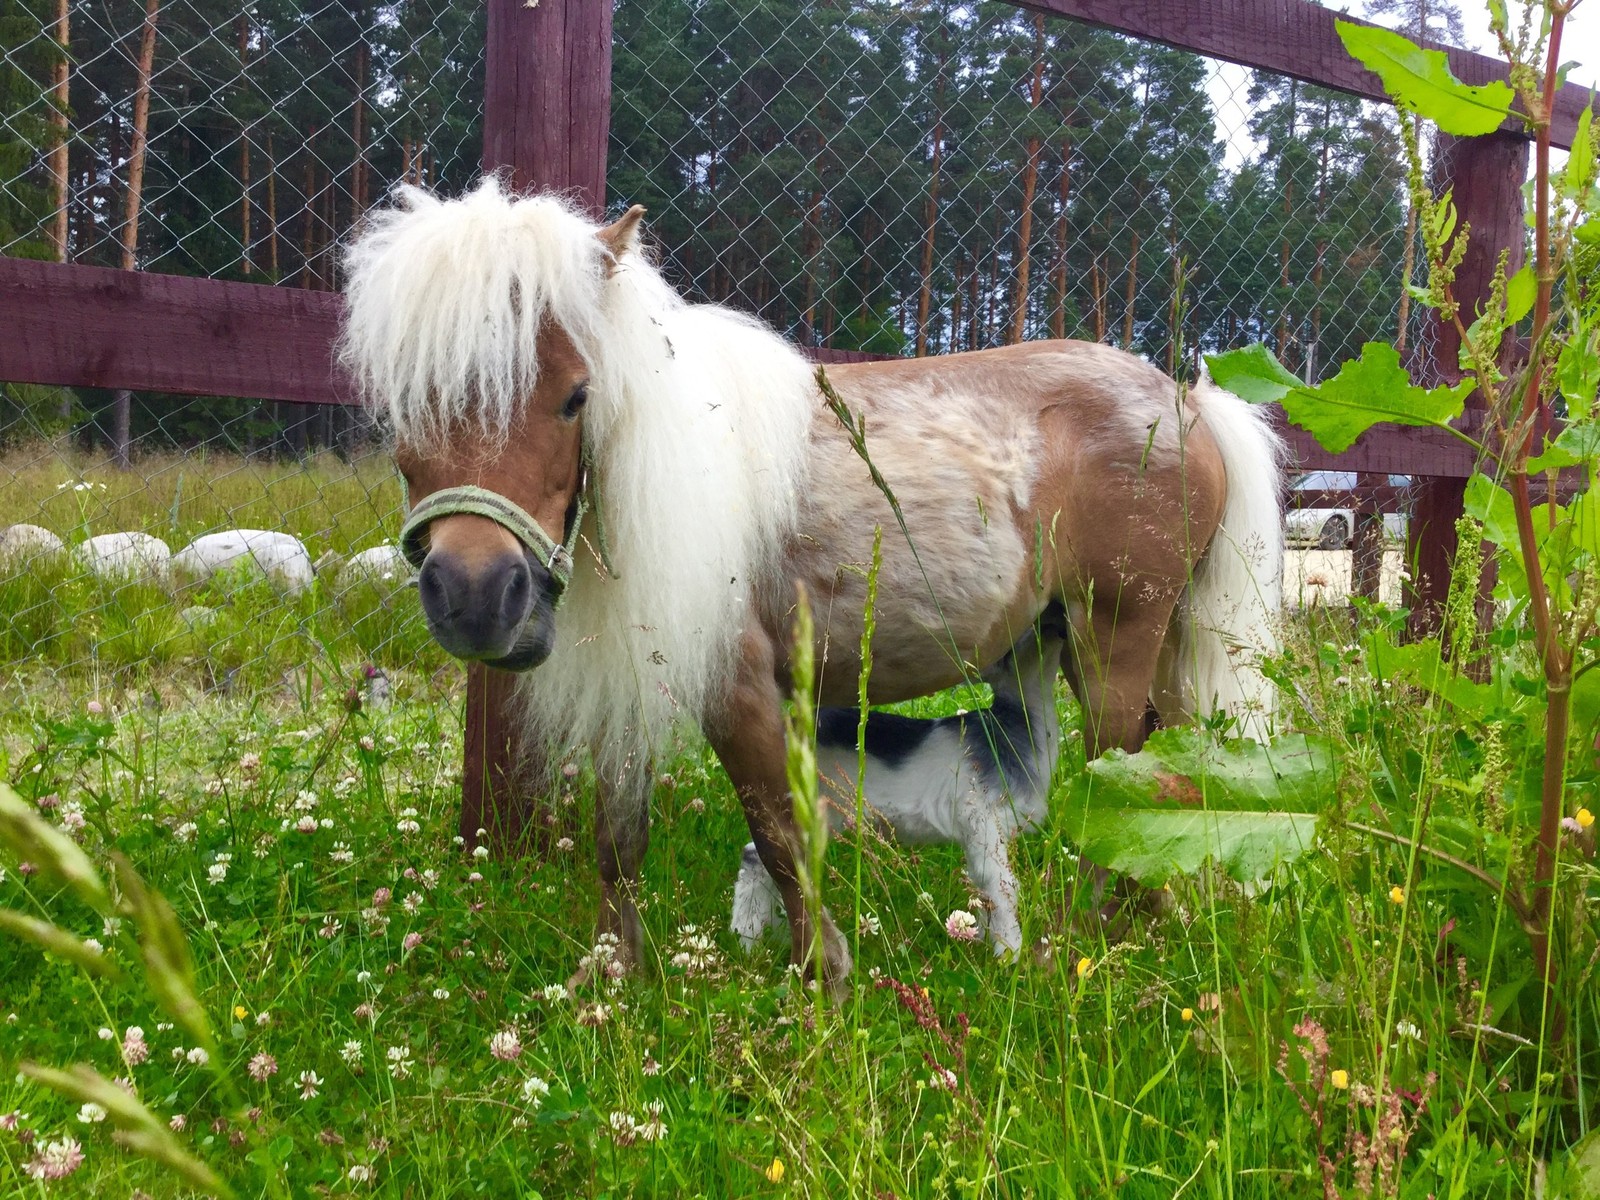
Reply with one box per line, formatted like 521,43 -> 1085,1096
1406,129 -> 1528,635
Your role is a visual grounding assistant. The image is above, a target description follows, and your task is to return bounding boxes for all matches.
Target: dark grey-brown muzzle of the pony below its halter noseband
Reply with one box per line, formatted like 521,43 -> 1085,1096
418,547 -> 549,670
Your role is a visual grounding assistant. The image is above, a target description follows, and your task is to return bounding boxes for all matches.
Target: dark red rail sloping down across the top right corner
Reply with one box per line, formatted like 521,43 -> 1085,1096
1018,0 -> 1589,147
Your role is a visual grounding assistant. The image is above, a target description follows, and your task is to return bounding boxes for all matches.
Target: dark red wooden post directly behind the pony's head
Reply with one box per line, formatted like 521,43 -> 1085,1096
461,0 -> 611,851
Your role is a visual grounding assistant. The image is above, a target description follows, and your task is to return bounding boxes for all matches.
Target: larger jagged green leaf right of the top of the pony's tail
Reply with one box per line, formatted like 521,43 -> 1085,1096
1283,342 -> 1474,454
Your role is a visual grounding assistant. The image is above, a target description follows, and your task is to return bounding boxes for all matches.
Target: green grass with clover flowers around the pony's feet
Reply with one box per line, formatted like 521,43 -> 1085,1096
0,448 -> 1600,1200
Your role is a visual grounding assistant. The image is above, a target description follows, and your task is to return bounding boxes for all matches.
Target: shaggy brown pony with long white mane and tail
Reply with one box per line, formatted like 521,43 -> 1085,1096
346,182 -> 1282,982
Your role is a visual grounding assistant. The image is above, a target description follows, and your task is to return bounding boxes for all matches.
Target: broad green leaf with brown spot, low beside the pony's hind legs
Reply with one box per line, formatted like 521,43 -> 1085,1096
1066,728 -> 1333,883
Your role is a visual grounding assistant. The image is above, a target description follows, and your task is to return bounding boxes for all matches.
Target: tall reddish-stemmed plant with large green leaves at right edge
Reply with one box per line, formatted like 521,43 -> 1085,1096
1208,0 -> 1600,1062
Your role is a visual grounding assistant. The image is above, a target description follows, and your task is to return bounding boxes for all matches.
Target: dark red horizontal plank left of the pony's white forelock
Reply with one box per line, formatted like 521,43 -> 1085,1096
0,258 -> 352,403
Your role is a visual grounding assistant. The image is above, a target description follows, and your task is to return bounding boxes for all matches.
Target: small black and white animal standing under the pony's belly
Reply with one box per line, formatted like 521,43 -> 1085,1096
733,608 -> 1067,954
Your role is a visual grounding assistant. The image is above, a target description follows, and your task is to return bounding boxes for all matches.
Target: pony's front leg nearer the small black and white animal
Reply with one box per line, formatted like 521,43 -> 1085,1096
706,622 -> 850,990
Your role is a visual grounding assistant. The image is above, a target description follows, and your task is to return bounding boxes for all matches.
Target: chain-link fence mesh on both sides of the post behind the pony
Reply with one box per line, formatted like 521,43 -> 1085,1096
0,0 -> 1427,720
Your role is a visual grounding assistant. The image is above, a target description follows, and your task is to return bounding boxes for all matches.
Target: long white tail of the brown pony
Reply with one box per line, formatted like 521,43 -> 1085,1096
1157,381 -> 1285,741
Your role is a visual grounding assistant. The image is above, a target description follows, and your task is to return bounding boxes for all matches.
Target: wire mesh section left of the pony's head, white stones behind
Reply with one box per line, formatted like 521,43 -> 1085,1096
0,0 -> 485,709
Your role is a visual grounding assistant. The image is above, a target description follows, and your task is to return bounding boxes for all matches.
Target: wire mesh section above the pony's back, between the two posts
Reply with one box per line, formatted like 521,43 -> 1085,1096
610,0 -> 1427,378
